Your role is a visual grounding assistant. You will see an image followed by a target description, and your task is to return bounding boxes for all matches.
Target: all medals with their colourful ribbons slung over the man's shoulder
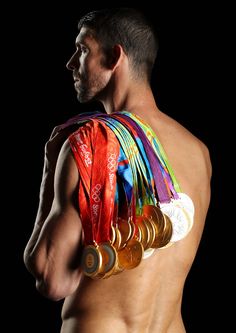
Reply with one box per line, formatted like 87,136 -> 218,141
61,111 -> 194,279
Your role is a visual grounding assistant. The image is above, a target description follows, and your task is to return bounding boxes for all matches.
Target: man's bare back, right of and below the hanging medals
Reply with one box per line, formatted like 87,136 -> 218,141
61,112 -> 211,333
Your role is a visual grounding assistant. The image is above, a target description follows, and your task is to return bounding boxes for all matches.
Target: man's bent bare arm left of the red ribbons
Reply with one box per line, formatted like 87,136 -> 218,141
24,137 -> 82,300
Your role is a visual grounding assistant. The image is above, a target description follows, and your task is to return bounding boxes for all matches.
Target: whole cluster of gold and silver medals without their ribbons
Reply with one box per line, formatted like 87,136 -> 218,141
82,193 -> 193,279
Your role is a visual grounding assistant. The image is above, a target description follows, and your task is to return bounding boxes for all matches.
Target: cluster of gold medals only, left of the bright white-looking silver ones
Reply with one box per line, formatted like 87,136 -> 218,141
82,205 -> 172,279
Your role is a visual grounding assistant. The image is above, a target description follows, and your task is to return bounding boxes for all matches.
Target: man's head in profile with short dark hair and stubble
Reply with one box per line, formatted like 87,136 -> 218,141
67,8 -> 157,103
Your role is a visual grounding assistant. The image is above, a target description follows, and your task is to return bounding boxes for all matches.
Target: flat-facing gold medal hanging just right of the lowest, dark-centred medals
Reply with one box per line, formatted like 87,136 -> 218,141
117,239 -> 144,269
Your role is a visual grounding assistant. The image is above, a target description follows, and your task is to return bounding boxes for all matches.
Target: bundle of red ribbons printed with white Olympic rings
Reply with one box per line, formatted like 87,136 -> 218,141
69,121 -> 119,244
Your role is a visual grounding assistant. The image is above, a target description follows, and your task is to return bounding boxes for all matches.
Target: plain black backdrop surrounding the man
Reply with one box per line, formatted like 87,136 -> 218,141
3,1 -> 228,333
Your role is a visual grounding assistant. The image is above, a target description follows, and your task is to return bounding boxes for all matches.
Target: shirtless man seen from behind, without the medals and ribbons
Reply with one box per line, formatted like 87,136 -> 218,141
24,9 -> 211,333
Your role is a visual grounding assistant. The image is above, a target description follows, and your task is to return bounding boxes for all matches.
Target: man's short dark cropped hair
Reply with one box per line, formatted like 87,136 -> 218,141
78,7 -> 158,80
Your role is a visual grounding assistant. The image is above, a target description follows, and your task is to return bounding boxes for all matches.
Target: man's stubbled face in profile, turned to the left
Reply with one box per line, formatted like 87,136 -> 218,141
67,27 -> 112,103
